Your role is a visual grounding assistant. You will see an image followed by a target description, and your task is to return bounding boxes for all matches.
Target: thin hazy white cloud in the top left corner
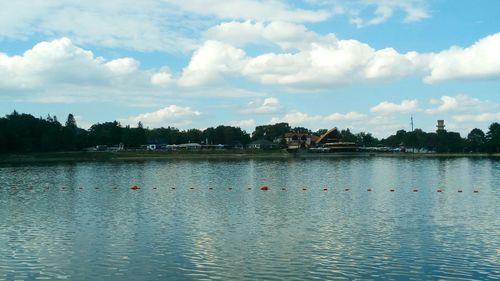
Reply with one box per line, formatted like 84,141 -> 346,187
0,0 -> 199,51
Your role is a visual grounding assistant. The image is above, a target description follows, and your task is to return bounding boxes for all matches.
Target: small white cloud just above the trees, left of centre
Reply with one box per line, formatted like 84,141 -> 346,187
120,105 -> 202,127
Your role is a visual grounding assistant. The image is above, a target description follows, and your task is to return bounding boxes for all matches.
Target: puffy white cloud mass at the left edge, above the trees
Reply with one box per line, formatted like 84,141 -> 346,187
0,38 -> 165,104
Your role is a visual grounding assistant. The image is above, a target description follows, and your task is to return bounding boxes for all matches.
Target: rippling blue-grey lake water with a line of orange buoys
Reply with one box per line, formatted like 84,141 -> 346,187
0,158 -> 500,280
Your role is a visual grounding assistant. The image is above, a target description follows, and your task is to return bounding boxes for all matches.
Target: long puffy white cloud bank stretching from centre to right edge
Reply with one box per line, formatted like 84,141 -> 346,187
191,30 -> 500,88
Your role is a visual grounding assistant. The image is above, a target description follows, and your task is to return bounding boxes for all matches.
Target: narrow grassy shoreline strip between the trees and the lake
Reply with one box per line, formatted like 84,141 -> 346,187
0,150 -> 500,164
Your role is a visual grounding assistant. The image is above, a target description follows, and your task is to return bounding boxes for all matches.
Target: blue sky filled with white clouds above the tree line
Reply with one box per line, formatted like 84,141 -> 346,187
0,0 -> 500,138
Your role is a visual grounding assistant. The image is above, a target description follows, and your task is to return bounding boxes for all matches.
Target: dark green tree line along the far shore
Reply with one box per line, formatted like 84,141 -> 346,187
0,111 -> 500,153
